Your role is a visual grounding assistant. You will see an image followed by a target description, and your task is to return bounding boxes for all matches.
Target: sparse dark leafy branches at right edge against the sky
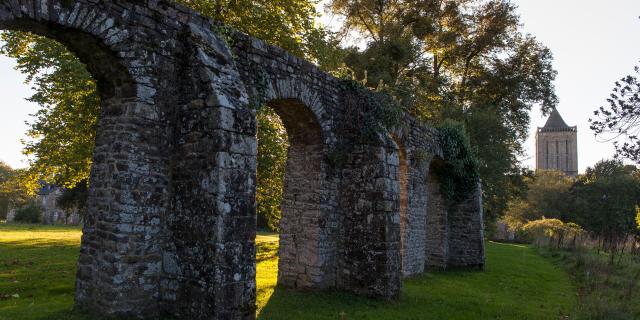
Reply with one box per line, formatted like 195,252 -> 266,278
589,66 -> 640,164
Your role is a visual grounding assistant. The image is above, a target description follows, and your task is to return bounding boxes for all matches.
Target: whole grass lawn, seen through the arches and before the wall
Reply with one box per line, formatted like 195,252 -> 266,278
0,224 -> 577,320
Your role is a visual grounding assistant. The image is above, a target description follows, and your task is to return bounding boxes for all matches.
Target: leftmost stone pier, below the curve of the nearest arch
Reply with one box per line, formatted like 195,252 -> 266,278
76,97 -> 168,316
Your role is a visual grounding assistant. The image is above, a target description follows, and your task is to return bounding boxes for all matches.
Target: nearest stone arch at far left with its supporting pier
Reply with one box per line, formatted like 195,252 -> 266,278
0,0 -> 175,315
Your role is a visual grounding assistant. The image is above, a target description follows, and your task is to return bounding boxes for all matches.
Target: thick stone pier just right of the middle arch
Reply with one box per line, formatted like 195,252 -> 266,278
338,145 -> 401,299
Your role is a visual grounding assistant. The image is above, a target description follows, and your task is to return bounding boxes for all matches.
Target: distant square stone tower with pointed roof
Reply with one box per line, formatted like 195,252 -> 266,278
536,109 -> 578,177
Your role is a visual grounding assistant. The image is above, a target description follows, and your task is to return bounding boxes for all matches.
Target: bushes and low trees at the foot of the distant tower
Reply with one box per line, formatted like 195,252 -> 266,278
504,160 -> 640,247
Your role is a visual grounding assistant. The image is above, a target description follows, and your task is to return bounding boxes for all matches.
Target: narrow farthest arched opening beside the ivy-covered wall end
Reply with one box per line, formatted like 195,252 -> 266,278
425,158 -> 449,269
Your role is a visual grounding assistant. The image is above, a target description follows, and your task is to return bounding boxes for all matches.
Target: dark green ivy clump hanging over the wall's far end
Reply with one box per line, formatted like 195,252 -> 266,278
436,120 -> 479,205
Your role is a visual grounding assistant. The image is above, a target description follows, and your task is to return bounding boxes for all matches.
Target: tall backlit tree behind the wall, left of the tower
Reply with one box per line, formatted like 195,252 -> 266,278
331,0 -> 557,220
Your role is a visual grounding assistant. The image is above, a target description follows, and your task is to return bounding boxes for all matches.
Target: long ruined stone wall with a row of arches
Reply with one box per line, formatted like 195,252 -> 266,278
0,0 -> 484,319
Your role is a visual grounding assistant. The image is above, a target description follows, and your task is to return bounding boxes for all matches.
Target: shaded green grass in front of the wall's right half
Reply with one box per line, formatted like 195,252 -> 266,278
260,242 -> 576,320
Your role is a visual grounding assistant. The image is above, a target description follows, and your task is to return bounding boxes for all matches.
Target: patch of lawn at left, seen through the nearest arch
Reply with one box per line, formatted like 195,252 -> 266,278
0,224 -> 82,320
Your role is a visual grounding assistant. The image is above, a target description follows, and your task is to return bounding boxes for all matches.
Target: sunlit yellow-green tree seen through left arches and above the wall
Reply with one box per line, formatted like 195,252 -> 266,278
0,0 -> 341,230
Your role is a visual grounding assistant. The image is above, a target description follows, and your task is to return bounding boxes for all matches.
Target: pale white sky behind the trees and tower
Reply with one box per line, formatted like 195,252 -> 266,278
0,0 -> 640,172
